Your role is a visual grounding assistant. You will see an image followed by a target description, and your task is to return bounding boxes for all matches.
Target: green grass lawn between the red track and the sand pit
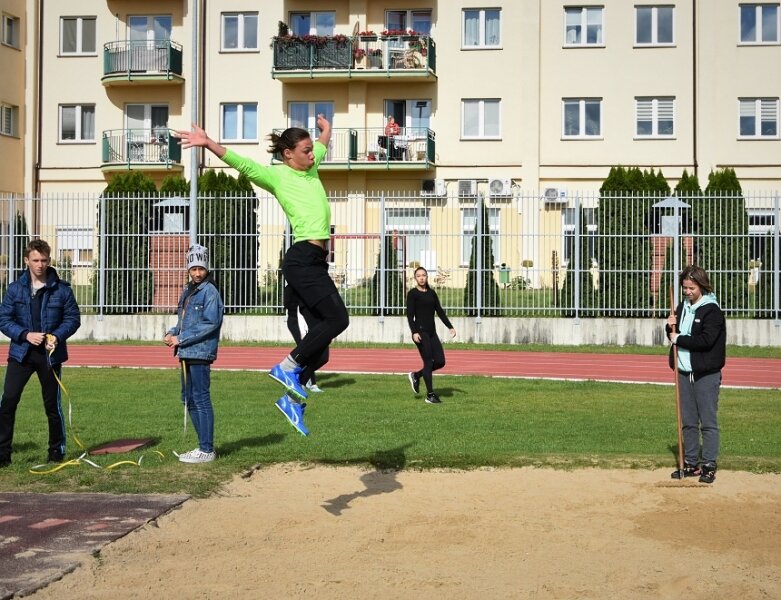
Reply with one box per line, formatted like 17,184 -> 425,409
0,366 -> 781,496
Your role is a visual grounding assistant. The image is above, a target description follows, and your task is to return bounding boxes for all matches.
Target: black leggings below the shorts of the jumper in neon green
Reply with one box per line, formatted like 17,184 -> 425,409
290,292 -> 350,382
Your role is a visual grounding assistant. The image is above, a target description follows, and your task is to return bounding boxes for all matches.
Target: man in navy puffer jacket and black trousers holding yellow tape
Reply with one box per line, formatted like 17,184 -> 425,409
0,240 -> 81,467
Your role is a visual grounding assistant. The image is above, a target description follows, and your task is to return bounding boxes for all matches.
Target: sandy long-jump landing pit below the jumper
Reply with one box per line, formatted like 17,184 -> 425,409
24,465 -> 781,600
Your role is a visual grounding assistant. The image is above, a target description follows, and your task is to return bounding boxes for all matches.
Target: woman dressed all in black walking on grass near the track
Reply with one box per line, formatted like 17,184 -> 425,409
407,267 -> 456,404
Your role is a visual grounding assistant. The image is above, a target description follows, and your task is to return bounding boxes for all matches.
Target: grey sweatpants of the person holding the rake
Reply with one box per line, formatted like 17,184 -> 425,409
678,372 -> 721,465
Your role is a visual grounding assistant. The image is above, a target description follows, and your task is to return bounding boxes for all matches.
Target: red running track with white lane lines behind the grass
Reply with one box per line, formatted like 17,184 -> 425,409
62,344 -> 781,389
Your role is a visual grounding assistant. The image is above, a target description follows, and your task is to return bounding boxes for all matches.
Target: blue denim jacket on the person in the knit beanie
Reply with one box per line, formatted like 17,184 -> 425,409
168,276 -> 223,362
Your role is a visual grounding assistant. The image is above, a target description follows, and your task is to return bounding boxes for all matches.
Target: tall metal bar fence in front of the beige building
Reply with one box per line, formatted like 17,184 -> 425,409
0,192 -> 781,319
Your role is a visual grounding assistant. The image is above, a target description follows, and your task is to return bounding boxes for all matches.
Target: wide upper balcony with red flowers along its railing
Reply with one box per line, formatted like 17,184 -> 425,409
271,35 -> 437,82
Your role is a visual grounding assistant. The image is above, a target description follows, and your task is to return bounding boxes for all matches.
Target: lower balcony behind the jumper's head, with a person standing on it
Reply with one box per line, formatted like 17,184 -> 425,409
272,127 -> 436,171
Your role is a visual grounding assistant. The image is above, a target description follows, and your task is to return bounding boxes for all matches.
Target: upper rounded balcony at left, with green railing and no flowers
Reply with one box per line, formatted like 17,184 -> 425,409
101,40 -> 184,87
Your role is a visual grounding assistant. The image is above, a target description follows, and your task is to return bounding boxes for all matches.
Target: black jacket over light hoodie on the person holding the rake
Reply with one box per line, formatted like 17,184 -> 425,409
665,303 -> 727,376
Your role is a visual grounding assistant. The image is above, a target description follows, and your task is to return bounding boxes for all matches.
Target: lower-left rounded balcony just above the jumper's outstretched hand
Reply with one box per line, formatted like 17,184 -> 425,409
101,128 -> 182,172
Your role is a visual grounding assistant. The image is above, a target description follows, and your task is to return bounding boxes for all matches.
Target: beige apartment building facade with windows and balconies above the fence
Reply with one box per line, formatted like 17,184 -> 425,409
6,0 -> 781,197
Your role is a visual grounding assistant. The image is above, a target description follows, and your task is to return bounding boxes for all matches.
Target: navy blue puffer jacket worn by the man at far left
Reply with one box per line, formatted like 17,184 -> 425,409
0,267 -> 81,365
